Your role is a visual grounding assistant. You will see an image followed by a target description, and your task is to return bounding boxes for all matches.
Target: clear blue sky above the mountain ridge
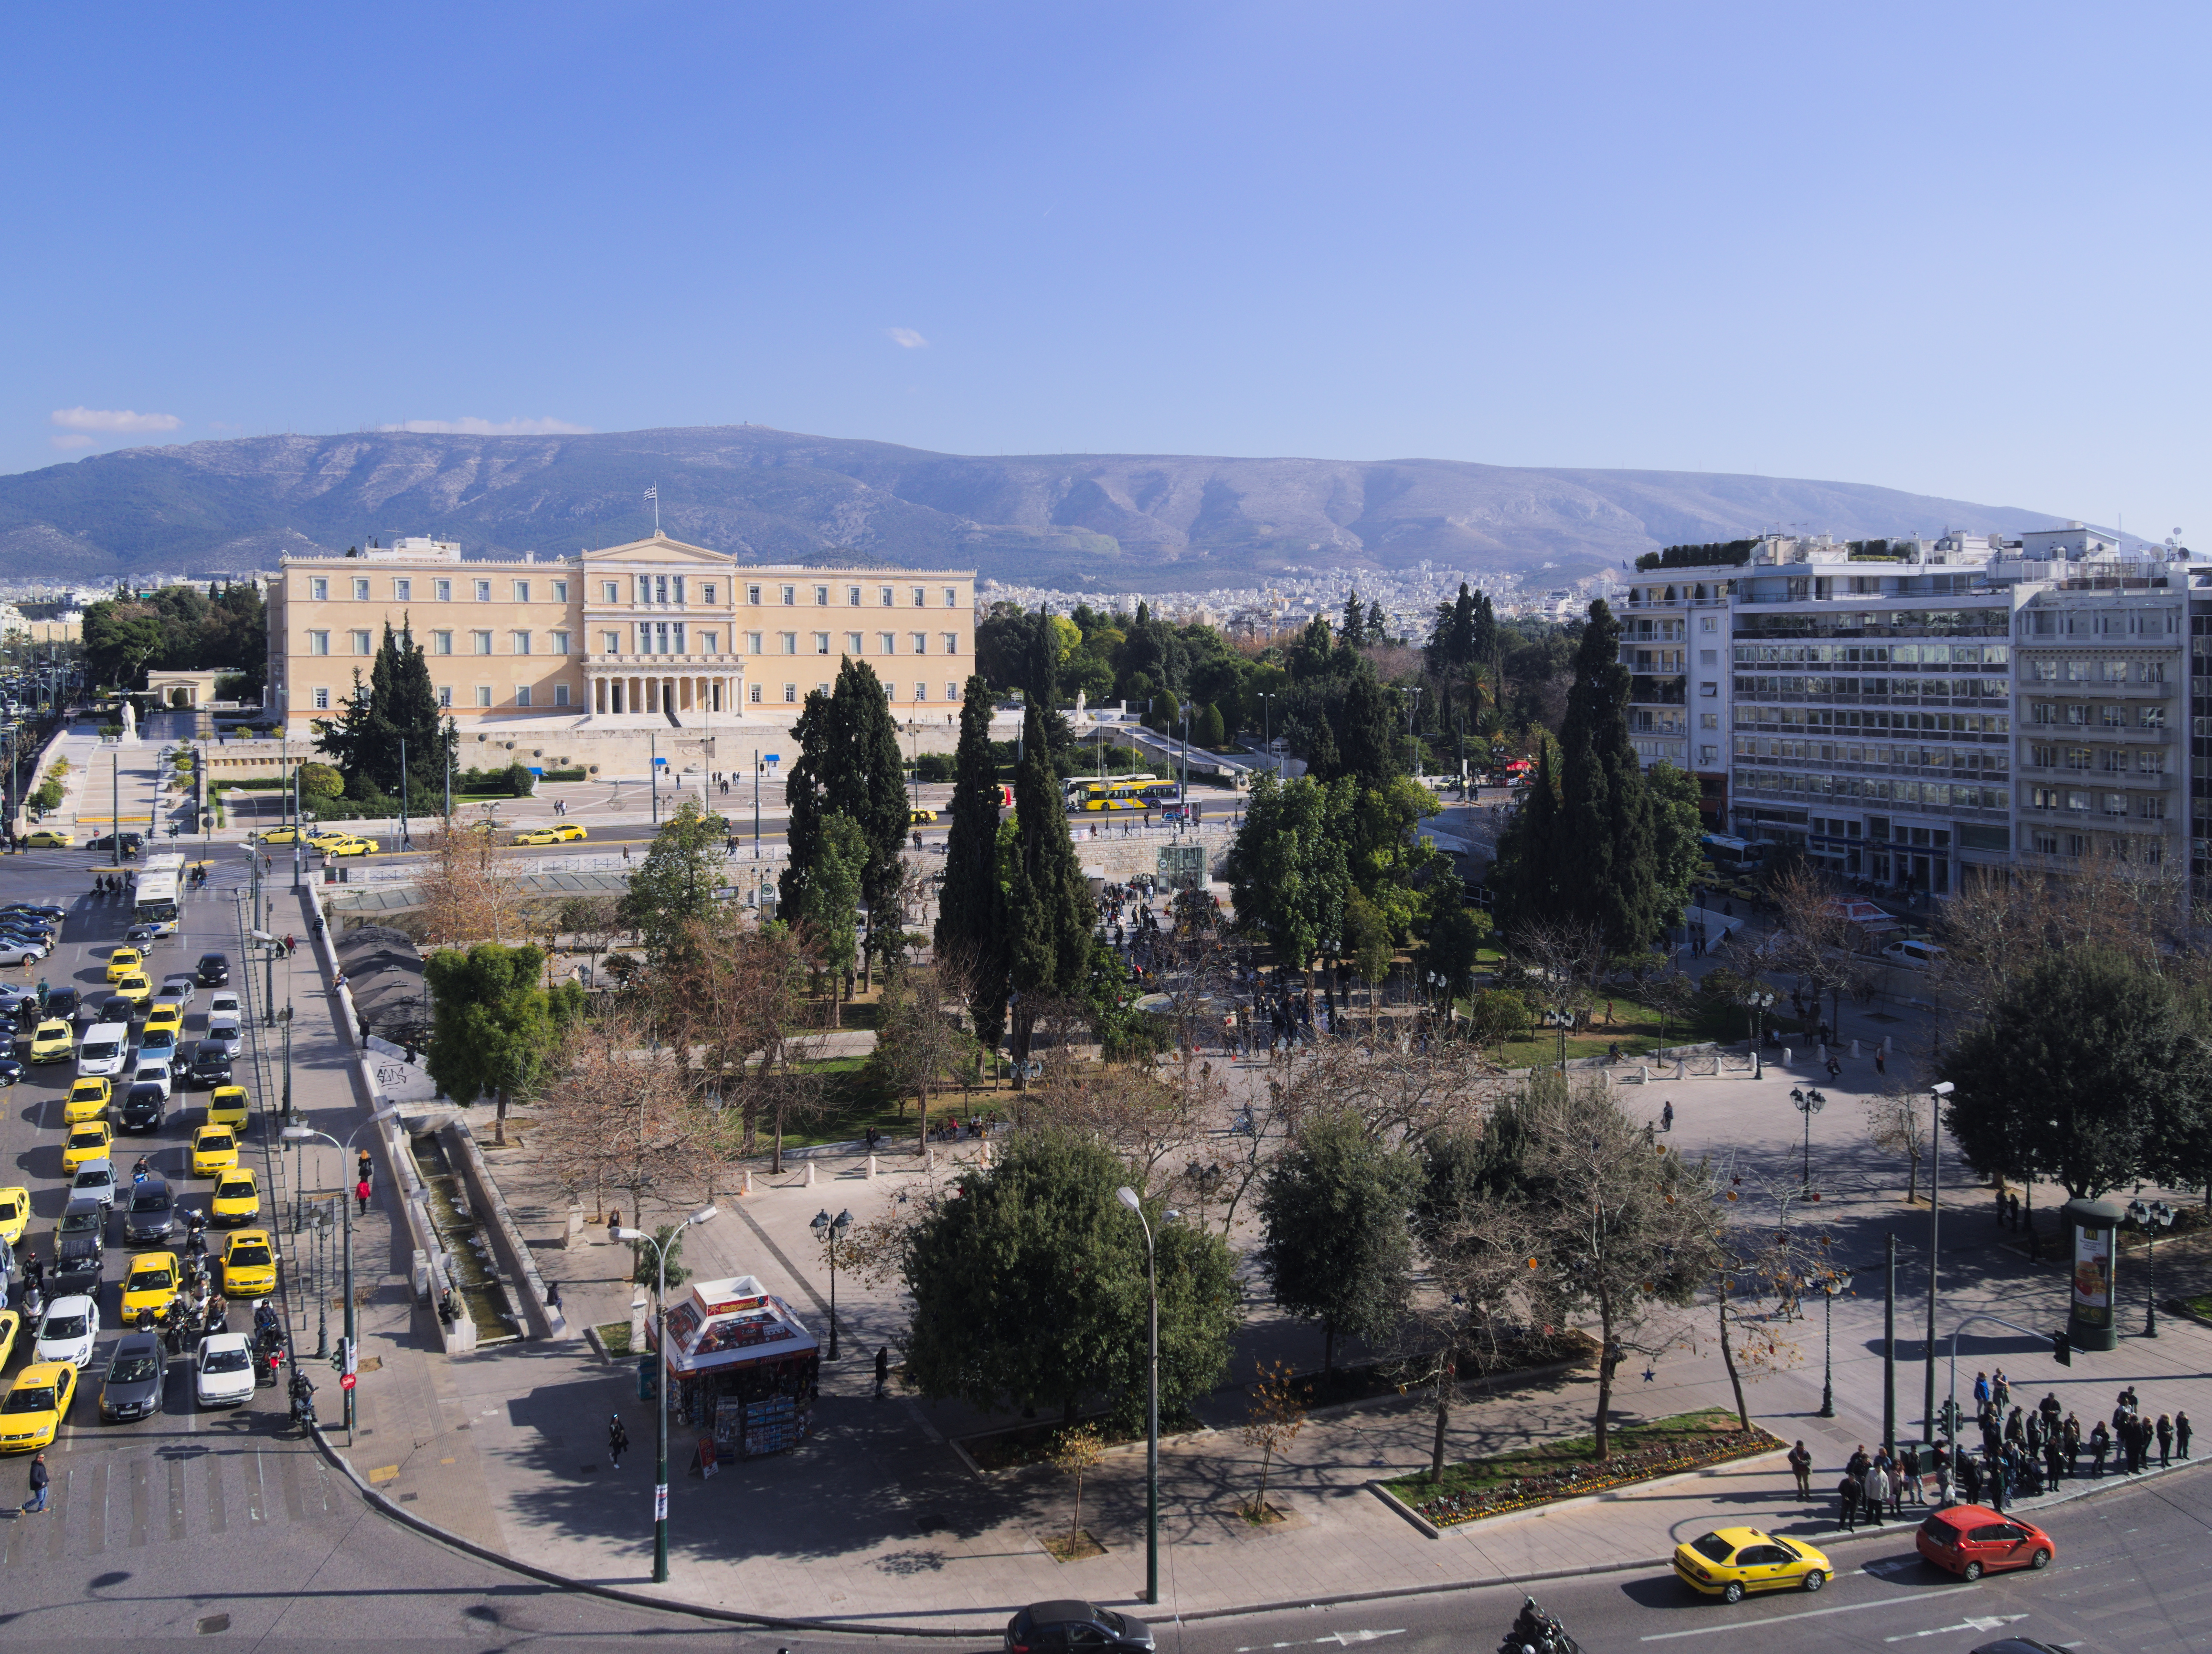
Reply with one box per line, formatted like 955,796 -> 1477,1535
0,0 -> 2212,544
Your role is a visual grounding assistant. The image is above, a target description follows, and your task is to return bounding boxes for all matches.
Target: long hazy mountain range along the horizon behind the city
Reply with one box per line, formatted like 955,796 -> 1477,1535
0,424 -> 2106,593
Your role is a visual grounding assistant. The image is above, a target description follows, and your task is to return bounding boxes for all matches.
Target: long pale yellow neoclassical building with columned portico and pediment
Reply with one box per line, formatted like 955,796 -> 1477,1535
267,535 -> 976,741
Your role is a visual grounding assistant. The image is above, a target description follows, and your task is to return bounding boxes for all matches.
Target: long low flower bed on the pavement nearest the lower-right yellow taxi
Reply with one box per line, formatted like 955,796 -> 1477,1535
1385,1411 -> 1785,1528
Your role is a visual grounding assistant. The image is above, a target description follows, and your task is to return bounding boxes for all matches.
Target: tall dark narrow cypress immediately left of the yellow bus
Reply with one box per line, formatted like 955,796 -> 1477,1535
1007,701 -> 1093,1061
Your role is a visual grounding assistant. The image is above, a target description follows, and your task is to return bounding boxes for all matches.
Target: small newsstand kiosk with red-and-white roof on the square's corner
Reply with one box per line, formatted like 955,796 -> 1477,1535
646,1276 -> 820,1459
